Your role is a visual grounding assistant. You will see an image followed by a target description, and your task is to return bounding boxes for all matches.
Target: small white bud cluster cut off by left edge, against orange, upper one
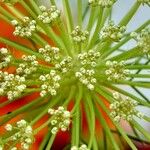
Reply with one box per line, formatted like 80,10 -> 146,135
0,48 -> 12,69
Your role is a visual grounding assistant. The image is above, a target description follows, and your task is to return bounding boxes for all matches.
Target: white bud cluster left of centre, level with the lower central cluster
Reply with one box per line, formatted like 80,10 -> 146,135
39,70 -> 61,97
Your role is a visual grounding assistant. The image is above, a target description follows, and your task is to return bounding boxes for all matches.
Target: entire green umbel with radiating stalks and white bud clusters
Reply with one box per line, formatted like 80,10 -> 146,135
0,0 -> 150,150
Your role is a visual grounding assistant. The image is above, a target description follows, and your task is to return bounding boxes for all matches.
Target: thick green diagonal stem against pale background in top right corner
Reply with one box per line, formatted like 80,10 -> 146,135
119,2 -> 141,26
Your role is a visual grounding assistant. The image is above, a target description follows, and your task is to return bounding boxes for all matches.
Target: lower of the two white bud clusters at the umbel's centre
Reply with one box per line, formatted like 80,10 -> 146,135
75,67 -> 96,90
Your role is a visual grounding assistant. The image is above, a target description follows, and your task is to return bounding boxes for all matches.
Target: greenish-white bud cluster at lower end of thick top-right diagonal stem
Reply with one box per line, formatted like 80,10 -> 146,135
99,21 -> 126,42
